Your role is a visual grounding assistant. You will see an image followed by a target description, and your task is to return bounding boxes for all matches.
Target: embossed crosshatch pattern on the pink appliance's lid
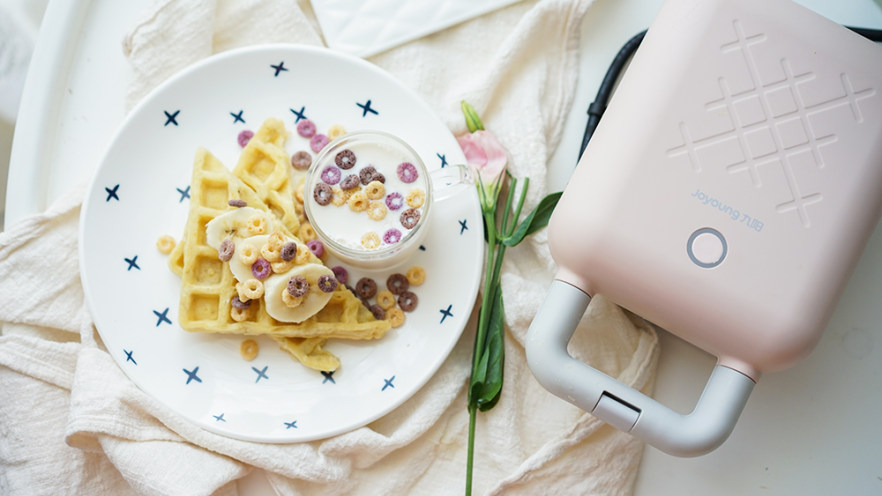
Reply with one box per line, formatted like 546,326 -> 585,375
667,19 -> 878,228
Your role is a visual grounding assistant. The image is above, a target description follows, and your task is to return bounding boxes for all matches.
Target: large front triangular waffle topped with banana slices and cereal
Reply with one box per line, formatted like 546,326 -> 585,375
179,149 -> 390,339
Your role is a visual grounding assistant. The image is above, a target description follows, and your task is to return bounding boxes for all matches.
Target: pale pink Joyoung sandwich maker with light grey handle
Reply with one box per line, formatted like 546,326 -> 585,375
526,0 -> 882,456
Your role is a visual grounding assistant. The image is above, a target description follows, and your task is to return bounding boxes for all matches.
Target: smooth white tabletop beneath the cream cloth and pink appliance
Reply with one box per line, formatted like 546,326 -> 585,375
5,0 -> 882,495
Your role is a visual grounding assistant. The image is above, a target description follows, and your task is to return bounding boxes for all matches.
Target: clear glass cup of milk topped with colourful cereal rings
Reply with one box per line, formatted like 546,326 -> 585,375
303,131 -> 472,269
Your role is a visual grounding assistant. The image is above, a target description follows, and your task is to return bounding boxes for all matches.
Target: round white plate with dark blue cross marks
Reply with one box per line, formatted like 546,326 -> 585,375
80,45 -> 483,442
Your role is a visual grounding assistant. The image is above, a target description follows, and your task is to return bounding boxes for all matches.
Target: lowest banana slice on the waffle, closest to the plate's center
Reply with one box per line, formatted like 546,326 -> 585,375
263,264 -> 334,323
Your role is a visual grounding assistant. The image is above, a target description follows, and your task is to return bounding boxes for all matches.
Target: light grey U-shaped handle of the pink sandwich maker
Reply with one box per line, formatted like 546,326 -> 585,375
526,280 -> 755,456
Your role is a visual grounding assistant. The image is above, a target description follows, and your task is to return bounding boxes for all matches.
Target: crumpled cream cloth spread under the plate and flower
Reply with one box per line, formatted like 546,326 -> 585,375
0,0 -> 658,495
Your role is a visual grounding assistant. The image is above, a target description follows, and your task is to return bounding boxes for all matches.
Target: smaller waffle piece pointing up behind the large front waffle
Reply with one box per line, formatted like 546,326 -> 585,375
233,118 -> 300,234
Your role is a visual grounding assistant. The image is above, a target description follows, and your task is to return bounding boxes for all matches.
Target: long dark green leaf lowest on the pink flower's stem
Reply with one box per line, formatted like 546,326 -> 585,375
474,287 -> 505,412
